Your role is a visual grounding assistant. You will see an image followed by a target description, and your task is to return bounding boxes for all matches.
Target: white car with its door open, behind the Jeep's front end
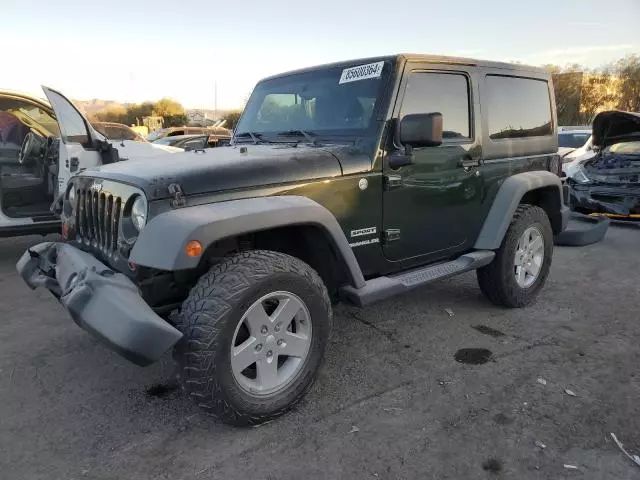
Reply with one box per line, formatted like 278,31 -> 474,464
0,87 -> 184,237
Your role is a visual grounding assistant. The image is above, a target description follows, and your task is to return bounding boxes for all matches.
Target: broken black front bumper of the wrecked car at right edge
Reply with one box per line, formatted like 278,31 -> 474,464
569,184 -> 640,220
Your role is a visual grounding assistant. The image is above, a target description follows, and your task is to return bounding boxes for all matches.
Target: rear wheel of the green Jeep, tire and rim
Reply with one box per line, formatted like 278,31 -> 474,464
477,204 -> 553,308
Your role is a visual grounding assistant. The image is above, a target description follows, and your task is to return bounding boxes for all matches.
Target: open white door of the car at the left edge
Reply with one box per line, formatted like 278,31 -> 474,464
42,87 -> 103,196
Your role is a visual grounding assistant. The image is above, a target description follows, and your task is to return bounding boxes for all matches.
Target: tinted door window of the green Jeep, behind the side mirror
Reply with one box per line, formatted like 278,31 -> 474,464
400,72 -> 471,141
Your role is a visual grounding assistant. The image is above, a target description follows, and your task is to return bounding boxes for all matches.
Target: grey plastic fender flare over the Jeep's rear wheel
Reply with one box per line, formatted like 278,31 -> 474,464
474,170 -> 563,250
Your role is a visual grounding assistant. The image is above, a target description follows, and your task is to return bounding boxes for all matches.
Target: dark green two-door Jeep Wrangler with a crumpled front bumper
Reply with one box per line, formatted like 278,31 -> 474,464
17,55 -> 568,424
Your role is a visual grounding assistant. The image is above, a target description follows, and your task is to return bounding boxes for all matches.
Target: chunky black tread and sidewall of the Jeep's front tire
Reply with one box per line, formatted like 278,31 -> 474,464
175,250 -> 332,425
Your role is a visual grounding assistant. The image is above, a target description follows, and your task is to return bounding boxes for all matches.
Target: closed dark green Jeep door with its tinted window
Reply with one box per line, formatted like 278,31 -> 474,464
383,63 -> 482,262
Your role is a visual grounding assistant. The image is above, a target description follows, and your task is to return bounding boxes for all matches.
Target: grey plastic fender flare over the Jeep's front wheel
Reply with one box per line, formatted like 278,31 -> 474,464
129,195 -> 365,288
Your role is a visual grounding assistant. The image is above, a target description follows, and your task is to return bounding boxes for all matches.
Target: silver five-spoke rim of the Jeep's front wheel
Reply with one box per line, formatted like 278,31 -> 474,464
231,292 -> 311,396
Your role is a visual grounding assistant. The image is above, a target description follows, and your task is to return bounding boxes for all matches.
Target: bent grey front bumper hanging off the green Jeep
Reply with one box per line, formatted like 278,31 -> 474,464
16,242 -> 182,365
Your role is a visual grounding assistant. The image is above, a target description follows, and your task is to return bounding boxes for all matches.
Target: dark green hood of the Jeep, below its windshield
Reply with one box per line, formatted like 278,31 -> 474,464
85,144 -> 342,200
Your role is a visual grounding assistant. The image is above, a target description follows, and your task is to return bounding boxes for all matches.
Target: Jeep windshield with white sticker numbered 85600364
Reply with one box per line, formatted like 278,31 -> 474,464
236,62 -> 391,141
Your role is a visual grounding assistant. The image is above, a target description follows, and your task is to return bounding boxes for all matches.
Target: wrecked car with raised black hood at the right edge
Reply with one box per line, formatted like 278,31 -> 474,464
567,111 -> 640,220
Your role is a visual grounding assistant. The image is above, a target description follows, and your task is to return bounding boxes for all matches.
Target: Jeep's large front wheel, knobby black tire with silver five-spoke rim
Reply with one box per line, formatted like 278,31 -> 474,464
175,250 -> 332,425
